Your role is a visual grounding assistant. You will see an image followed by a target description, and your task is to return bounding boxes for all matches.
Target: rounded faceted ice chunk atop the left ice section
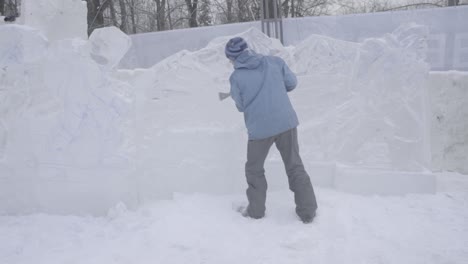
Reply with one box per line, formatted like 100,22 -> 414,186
89,27 -> 132,68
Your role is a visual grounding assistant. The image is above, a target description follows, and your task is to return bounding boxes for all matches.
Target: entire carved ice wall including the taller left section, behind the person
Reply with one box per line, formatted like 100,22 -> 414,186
0,25 -> 435,213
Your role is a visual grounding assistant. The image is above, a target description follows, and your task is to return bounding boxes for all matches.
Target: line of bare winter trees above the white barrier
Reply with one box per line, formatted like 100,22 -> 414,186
82,0 -> 459,34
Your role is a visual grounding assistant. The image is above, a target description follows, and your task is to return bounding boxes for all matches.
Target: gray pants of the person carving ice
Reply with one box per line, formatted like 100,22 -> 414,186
245,128 -> 317,220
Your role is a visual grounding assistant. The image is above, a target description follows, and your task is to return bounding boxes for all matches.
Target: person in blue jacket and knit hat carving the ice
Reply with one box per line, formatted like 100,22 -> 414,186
225,37 -> 317,223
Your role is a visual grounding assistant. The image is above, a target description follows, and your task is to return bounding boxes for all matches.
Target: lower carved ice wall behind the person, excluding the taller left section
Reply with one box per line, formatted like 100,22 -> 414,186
112,24 -> 433,204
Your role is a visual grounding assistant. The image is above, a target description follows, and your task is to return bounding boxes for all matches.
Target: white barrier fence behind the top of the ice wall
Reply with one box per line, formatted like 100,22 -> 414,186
121,6 -> 468,71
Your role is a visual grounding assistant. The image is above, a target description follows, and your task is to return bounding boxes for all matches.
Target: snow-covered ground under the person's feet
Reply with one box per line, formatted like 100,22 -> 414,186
0,173 -> 468,264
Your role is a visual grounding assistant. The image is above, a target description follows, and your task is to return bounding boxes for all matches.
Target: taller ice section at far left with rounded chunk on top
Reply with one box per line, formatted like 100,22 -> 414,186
0,25 -> 136,213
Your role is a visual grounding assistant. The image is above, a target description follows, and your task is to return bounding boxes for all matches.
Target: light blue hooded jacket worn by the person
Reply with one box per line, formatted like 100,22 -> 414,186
229,50 -> 299,140
